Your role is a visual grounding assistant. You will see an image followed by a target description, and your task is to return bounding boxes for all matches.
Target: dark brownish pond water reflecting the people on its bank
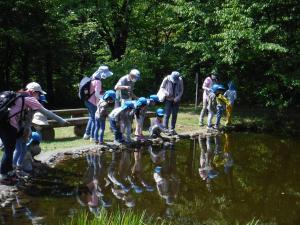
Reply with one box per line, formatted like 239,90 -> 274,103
0,133 -> 300,224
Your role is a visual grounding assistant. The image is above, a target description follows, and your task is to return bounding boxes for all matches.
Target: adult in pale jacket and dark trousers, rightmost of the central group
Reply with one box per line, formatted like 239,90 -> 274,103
160,71 -> 183,135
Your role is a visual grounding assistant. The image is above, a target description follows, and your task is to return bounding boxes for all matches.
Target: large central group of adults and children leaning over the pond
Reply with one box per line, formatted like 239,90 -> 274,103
83,66 -> 183,144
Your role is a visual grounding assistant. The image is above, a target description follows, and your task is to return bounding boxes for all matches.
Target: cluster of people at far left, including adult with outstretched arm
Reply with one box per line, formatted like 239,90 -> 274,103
0,82 -> 67,185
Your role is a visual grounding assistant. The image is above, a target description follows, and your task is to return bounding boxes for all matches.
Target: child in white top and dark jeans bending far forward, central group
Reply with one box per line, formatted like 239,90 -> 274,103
108,101 -> 134,144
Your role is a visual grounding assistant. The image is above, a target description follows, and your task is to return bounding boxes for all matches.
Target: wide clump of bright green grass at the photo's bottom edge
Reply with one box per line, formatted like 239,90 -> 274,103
62,209 -> 167,225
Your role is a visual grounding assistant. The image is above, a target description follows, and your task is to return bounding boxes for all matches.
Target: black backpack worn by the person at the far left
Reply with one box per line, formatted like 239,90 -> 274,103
0,91 -> 24,124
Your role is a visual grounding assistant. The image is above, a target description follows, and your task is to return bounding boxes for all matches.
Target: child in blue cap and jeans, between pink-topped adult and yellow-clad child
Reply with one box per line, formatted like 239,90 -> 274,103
212,84 -> 230,129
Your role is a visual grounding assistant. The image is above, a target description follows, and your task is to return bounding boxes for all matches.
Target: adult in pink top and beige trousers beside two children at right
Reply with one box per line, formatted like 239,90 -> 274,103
199,71 -> 217,126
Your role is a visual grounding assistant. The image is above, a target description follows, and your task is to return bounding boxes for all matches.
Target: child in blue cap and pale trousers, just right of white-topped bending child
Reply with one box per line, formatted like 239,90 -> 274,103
134,97 -> 147,141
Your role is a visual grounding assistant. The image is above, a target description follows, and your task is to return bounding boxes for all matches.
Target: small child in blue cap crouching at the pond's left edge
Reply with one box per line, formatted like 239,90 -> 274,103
22,131 -> 41,173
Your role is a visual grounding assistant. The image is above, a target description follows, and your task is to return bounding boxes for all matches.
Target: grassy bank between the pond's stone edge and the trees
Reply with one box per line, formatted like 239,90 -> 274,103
0,105 -> 300,156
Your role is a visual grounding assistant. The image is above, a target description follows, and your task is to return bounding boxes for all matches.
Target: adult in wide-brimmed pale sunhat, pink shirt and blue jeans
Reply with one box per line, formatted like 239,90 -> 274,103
83,66 -> 113,141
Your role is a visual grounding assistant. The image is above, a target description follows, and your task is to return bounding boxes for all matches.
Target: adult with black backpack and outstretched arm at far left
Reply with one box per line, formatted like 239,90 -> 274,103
0,82 -> 67,185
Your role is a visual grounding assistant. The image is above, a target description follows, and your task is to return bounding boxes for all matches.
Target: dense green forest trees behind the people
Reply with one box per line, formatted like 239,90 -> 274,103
0,0 -> 300,112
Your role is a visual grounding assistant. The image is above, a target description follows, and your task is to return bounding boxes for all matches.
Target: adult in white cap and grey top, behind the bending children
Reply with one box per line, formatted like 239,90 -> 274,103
115,69 -> 141,106
